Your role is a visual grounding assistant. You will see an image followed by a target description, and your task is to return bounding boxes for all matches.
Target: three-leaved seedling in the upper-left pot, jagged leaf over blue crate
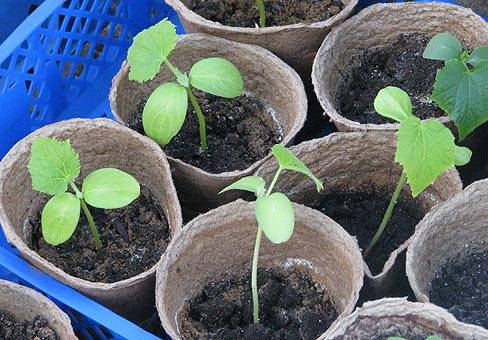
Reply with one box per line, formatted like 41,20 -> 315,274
127,19 -> 244,152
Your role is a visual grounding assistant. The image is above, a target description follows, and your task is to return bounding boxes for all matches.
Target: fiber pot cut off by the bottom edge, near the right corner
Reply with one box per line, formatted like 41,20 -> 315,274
324,298 -> 488,340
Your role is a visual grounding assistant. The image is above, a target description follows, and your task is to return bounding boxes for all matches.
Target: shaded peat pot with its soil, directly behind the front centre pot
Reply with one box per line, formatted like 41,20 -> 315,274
257,131 -> 461,298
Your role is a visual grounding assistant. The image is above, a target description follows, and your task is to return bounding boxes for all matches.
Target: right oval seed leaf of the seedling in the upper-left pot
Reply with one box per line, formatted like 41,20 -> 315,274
189,58 -> 244,98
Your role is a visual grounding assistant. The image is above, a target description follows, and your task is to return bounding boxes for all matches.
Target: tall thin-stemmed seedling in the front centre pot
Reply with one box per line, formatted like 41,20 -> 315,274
220,144 -> 324,323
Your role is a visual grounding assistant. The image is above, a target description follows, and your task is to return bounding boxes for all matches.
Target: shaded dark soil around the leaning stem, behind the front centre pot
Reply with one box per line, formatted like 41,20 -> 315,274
305,187 -> 425,275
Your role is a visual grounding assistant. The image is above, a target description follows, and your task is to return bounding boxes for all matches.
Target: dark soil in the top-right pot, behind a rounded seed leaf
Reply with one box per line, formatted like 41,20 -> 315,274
336,34 -> 444,124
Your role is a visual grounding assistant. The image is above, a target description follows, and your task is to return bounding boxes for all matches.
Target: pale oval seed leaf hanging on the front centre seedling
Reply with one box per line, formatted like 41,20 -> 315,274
256,192 -> 295,244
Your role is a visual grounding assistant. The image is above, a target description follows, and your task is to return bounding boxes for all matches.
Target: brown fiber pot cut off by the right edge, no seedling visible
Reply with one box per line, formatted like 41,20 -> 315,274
407,180 -> 488,302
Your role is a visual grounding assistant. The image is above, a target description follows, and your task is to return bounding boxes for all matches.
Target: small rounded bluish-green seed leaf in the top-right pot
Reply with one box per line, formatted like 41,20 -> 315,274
423,33 -> 463,61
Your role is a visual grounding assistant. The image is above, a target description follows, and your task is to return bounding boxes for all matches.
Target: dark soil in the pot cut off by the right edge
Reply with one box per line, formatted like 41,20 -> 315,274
429,248 -> 488,328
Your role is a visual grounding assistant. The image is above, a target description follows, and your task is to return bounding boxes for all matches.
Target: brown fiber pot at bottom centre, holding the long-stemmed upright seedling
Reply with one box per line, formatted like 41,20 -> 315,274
156,200 -> 363,339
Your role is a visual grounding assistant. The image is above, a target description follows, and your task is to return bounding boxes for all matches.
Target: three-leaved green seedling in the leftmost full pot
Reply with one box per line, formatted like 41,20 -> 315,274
28,137 -> 140,250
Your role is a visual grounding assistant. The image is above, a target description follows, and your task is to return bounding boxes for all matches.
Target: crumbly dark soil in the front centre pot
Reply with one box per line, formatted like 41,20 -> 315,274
180,269 -> 338,340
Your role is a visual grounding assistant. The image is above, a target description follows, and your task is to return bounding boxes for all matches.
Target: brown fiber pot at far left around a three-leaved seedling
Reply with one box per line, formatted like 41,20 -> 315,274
0,119 -> 182,316
